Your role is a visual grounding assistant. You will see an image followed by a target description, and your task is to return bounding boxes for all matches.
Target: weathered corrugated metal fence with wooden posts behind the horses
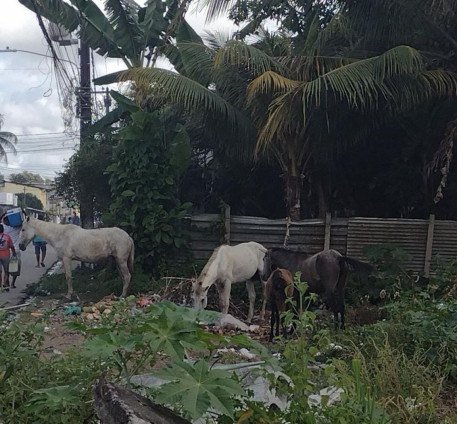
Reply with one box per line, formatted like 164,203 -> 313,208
186,207 -> 457,276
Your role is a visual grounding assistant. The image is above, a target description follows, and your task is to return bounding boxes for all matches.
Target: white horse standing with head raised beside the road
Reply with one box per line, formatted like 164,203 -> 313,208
19,216 -> 135,298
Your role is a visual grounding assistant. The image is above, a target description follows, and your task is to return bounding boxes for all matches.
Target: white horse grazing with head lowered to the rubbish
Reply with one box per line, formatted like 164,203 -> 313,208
192,241 -> 267,322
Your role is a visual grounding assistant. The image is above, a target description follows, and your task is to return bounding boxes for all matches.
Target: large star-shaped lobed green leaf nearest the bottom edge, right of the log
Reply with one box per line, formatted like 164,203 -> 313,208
154,360 -> 245,419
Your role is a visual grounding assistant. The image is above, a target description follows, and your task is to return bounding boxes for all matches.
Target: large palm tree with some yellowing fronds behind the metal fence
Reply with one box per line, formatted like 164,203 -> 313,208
94,16 -> 456,219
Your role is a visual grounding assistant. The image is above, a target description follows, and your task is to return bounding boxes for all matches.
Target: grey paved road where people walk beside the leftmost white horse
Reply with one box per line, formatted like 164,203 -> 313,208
0,244 -> 57,307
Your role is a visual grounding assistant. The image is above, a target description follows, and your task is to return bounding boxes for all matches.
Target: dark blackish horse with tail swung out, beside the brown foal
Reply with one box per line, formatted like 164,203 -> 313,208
262,247 -> 373,329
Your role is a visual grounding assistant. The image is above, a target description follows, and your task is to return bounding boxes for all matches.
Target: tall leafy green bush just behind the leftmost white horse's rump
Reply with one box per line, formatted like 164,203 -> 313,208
103,110 -> 190,269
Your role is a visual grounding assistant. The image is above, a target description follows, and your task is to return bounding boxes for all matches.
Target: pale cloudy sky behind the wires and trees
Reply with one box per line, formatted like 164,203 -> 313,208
0,0 -> 235,178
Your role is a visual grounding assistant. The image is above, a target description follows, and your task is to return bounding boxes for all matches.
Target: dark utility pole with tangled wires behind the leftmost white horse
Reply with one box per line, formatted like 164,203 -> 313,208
78,39 -> 94,228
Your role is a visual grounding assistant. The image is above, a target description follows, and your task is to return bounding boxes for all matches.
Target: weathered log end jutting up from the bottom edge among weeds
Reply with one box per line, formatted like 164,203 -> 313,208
94,377 -> 190,424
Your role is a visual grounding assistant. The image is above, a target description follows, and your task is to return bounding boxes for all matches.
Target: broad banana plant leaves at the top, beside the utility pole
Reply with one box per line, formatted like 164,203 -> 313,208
19,0 -> 187,68
